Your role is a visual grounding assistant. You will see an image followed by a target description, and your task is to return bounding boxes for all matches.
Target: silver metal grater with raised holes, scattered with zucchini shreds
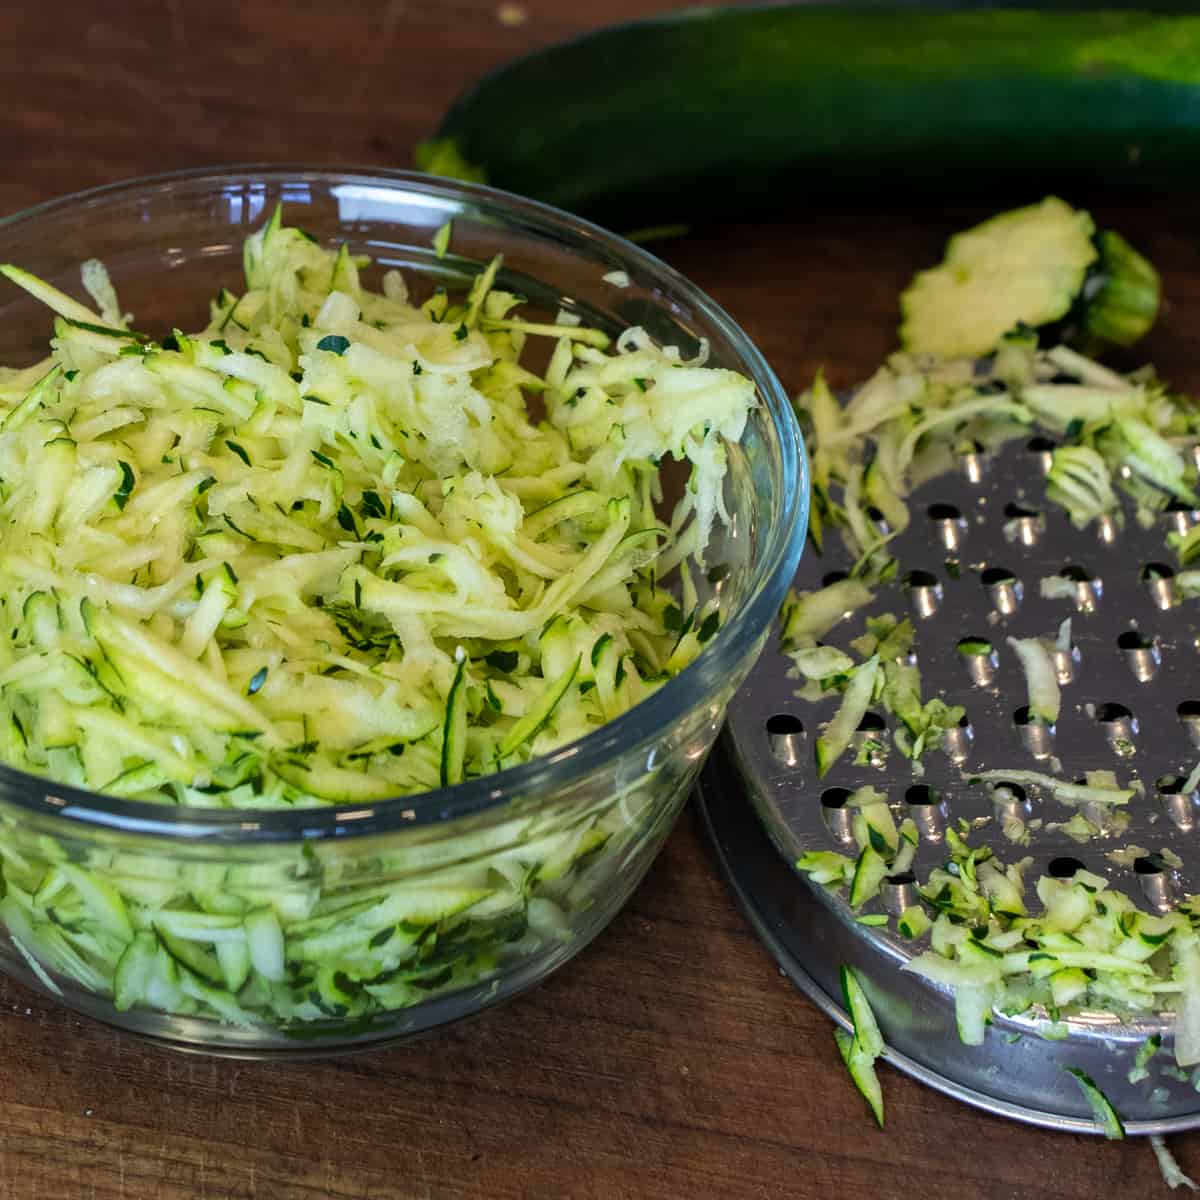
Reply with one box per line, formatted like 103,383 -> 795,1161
700,438 -> 1200,1133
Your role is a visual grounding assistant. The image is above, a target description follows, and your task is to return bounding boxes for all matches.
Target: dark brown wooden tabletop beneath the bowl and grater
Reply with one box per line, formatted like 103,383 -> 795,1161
0,0 -> 1200,1200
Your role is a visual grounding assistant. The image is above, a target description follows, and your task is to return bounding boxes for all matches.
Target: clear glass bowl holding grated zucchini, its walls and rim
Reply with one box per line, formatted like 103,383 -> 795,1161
0,167 -> 808,1056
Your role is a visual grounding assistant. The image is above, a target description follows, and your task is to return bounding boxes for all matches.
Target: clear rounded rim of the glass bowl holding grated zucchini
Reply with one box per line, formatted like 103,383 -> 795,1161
0,163 -> 809,844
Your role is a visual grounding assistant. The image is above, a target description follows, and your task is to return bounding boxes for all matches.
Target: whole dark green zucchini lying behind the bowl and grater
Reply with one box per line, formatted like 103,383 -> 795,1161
418,0 -> 1200,223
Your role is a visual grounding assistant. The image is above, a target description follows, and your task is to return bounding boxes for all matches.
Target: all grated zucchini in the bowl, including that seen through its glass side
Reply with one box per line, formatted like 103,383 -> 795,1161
0,210 -> 755,1027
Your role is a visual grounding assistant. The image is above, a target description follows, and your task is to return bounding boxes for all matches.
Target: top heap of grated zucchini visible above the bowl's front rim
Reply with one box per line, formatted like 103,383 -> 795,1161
0,211 -> 755,808
